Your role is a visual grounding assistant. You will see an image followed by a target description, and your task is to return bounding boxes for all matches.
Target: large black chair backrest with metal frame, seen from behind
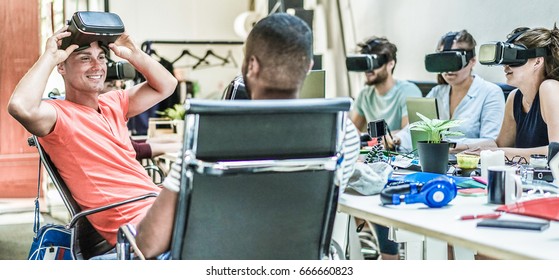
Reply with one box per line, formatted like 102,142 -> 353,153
171,98 -> 351,259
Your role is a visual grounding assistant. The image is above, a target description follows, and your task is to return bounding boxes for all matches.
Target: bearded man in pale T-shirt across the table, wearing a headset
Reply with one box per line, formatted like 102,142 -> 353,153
351,37 -> 422,140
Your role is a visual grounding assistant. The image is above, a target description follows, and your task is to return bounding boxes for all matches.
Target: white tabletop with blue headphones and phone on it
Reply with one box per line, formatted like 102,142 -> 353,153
338,193 -> 559,260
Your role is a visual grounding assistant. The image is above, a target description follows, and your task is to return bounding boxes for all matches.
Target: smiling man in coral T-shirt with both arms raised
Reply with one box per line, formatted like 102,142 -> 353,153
8,23 -> 177,245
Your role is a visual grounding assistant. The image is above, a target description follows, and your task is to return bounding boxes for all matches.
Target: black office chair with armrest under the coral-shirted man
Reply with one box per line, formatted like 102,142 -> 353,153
27,135 -> 157,260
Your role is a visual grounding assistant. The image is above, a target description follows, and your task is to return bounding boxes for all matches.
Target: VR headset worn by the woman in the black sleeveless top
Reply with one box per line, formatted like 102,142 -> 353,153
479,42 -> 549,67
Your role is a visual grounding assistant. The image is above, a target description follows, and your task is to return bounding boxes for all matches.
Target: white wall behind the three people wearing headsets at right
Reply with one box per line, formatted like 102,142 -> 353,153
342,0 -> 559,96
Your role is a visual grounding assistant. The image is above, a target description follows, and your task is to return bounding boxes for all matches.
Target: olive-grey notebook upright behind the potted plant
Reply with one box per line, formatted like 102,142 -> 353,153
406,97 -> 439,154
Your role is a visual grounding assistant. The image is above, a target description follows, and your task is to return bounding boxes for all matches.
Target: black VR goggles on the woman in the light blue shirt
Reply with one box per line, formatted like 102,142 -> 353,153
425,32 -> 476,73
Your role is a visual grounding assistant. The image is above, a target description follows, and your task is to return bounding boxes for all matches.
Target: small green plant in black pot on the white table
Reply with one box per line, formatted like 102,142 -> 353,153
410,113 -> 464,174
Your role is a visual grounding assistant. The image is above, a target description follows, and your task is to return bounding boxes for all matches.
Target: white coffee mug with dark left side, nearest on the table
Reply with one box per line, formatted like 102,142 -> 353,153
487,166 -> 522,204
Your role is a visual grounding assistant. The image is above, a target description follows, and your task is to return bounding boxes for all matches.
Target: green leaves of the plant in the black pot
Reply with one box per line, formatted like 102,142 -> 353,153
410,112 -> 464,143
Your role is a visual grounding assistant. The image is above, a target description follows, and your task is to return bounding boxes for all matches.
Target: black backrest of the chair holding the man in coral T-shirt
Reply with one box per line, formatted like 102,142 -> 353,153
28,135 -> 113,260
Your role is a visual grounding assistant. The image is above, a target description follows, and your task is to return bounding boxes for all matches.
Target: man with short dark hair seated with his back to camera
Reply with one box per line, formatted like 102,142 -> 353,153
132,13 -> 359,258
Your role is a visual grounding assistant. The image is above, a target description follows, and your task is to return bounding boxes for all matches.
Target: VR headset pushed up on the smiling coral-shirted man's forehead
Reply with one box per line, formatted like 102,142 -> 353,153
60,12 -> 124,50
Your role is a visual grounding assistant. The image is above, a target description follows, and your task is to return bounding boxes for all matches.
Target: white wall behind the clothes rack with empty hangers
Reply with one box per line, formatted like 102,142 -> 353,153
110,0 -> 249,98
